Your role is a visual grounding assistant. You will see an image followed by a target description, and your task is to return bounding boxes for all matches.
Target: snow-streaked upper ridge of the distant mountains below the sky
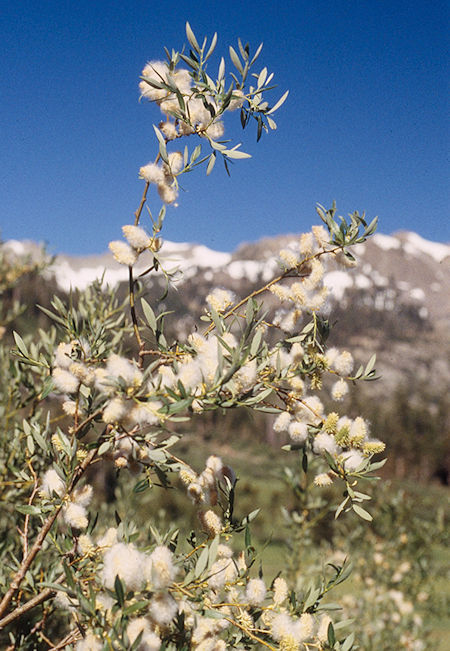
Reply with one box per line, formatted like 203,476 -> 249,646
4,232 -> 450,329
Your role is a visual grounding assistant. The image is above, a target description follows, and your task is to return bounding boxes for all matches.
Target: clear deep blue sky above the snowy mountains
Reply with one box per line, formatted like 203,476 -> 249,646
0,0 -> 450,254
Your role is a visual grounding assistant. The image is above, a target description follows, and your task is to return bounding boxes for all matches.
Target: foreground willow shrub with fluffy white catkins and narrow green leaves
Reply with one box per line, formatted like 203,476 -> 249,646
0,25 -> 418,651
